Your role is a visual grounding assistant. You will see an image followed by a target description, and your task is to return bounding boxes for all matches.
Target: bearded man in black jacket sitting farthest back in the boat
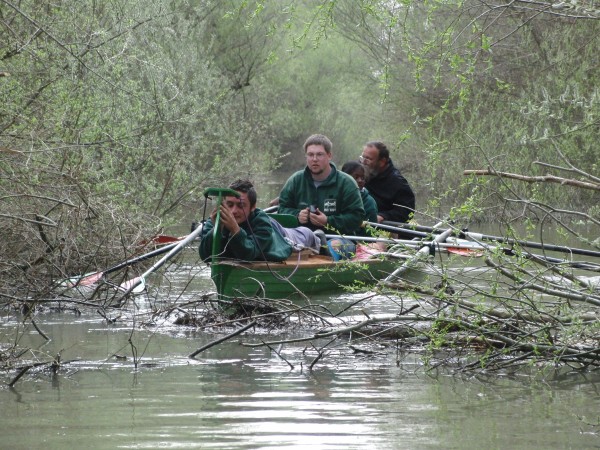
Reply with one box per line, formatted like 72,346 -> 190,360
359,141 -> 415,223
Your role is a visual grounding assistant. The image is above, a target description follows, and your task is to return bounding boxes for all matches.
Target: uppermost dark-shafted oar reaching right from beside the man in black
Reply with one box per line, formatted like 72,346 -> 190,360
366,222 -> 600,257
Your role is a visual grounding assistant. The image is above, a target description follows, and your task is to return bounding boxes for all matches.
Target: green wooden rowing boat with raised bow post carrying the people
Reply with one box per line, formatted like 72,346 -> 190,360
204,188 -> 418,299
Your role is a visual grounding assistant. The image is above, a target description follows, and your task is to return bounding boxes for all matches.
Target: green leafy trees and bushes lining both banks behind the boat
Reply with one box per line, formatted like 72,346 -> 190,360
0,0 -> 600,378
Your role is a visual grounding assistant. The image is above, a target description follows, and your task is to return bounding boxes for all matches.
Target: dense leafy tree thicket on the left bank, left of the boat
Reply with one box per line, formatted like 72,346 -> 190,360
0,0 -> 272,298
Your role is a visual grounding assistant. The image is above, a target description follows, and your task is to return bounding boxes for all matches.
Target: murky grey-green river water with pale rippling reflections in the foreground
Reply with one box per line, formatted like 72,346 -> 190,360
0,246 -> 600,450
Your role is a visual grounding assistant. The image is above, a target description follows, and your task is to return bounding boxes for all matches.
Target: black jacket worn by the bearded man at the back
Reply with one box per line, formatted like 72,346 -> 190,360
366,159 -> 415,222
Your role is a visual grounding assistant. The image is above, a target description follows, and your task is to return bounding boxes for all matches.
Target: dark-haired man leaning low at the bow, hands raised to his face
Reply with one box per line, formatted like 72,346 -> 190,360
199,180 -> 321,261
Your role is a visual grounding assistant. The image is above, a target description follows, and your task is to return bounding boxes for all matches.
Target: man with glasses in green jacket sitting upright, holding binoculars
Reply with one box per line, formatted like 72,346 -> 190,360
279,134 -> 365,260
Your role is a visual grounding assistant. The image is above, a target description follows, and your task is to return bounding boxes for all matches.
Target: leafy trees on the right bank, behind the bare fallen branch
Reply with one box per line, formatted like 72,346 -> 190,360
240,0 -> 600,221
